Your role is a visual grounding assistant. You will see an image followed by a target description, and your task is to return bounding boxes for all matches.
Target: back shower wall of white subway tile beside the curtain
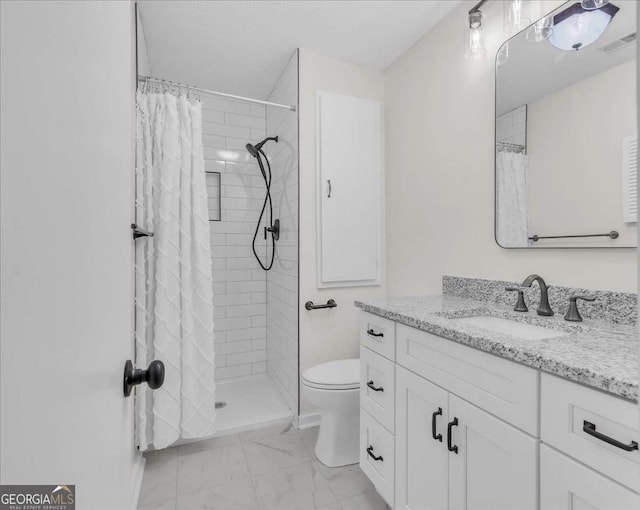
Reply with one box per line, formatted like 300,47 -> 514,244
202,96 -> 267,380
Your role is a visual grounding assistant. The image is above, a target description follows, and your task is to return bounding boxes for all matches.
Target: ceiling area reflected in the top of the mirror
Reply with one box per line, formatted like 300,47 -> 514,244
496,0 -> 638,114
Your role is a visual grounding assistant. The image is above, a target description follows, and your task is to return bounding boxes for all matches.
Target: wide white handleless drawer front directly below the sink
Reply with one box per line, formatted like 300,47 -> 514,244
396,324 -> 540,437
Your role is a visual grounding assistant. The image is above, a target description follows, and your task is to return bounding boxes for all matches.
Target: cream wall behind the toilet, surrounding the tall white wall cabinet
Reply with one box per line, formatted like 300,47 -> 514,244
299,49 -> 385,414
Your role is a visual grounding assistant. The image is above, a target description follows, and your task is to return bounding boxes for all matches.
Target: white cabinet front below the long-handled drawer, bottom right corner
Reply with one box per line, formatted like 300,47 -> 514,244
540,445 -> 640,510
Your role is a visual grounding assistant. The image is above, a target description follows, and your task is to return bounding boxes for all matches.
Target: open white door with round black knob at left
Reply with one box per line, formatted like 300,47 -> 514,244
0,1 -> 140,510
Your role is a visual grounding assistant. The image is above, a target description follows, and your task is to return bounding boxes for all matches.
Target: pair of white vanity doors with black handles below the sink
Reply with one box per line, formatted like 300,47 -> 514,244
396,367 -> 538,510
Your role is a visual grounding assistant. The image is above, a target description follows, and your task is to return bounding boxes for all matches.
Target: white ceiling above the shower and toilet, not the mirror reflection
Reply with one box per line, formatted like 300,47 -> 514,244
138,0 -> 460,99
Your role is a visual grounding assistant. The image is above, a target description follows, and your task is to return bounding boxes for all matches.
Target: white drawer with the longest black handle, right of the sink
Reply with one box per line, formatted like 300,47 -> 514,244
541,374 -> 640,491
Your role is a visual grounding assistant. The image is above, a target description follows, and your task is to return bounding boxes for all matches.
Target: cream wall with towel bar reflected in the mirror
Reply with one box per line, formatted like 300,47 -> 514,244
527,60 -> 638,246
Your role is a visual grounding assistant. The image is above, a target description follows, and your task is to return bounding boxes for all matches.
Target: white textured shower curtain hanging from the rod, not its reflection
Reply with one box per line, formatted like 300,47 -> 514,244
135,91 -> 215,451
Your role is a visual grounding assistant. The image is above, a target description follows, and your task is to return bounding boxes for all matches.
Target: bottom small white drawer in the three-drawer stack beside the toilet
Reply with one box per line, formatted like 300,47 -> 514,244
360,408 -> 395,508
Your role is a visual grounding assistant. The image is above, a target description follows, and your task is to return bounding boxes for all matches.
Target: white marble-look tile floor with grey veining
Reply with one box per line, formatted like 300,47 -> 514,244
138,425 -> 388,510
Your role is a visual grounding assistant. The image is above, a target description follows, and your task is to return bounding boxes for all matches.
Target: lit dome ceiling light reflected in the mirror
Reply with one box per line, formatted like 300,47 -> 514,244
549,2 -> 620,51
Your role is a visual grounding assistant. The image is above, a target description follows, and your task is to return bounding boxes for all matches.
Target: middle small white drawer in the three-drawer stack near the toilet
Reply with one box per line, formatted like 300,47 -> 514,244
360,347 -> 395,433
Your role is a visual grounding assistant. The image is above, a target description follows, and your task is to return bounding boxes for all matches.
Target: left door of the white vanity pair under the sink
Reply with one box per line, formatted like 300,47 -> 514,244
396,367 -> 449,510
